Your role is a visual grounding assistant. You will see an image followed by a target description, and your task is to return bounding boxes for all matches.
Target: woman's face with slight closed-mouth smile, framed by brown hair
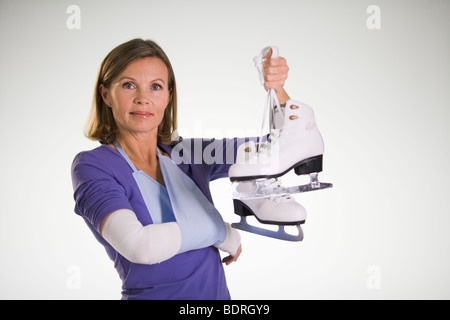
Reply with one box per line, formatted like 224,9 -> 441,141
100,57 -> 170,136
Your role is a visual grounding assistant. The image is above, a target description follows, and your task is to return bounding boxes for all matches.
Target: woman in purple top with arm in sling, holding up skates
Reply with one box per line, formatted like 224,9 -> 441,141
72,39 -> 289,299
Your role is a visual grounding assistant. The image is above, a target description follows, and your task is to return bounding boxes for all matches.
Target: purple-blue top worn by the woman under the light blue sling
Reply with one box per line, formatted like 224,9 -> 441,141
72,139 -> 245,300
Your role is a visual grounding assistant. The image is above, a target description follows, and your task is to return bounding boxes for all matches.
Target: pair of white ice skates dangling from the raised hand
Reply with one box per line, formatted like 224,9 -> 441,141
229,47 -> 332,241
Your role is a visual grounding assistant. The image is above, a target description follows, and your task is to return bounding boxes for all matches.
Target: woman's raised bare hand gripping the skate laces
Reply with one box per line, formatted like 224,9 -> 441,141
263,49 -> 290,103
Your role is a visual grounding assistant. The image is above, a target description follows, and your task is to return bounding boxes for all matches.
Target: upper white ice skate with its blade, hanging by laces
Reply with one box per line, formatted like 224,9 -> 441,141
228,49 -> 332,199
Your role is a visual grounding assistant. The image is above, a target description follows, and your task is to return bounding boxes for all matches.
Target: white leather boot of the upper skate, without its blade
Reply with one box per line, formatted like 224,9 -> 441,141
228,100 -> 324,181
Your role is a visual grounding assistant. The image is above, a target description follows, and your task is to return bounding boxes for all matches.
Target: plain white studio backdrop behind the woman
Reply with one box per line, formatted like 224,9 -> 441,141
0,0 -> 450,299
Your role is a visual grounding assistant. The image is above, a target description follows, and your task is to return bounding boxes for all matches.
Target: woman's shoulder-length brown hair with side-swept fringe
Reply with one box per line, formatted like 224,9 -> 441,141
86,39 -> 177,144
